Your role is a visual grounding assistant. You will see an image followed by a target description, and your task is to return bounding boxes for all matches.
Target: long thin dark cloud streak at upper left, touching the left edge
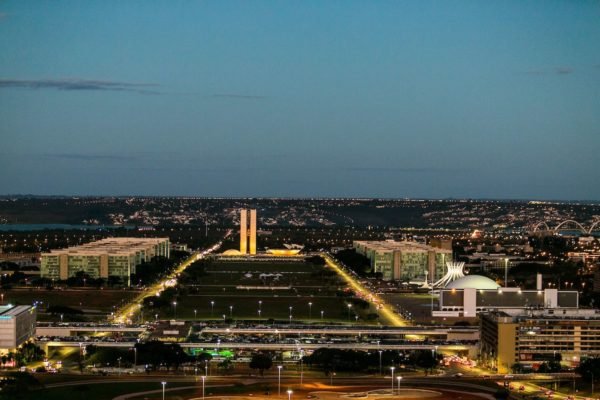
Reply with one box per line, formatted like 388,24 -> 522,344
0,78 -> 160,94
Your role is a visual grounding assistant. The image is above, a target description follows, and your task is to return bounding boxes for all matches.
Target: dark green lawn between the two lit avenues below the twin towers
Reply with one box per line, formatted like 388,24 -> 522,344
144,261 -> 374,323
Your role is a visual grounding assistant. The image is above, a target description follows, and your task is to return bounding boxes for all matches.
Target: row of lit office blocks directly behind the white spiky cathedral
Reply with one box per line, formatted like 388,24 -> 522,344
353,240 -> 452,282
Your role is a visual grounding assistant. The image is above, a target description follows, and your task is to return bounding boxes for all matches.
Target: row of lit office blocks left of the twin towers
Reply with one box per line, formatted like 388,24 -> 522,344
41,238 -> 170,280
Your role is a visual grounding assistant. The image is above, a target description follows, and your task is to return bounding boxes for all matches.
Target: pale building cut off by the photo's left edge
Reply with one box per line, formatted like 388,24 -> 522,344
0,305 -> 37,353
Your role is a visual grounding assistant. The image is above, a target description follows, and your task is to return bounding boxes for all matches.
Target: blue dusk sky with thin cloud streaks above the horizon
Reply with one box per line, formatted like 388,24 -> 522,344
0,0 -> 600,200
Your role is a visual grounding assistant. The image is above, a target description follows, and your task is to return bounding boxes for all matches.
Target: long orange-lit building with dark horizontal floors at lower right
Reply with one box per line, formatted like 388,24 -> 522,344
480,309 -> 600,373
